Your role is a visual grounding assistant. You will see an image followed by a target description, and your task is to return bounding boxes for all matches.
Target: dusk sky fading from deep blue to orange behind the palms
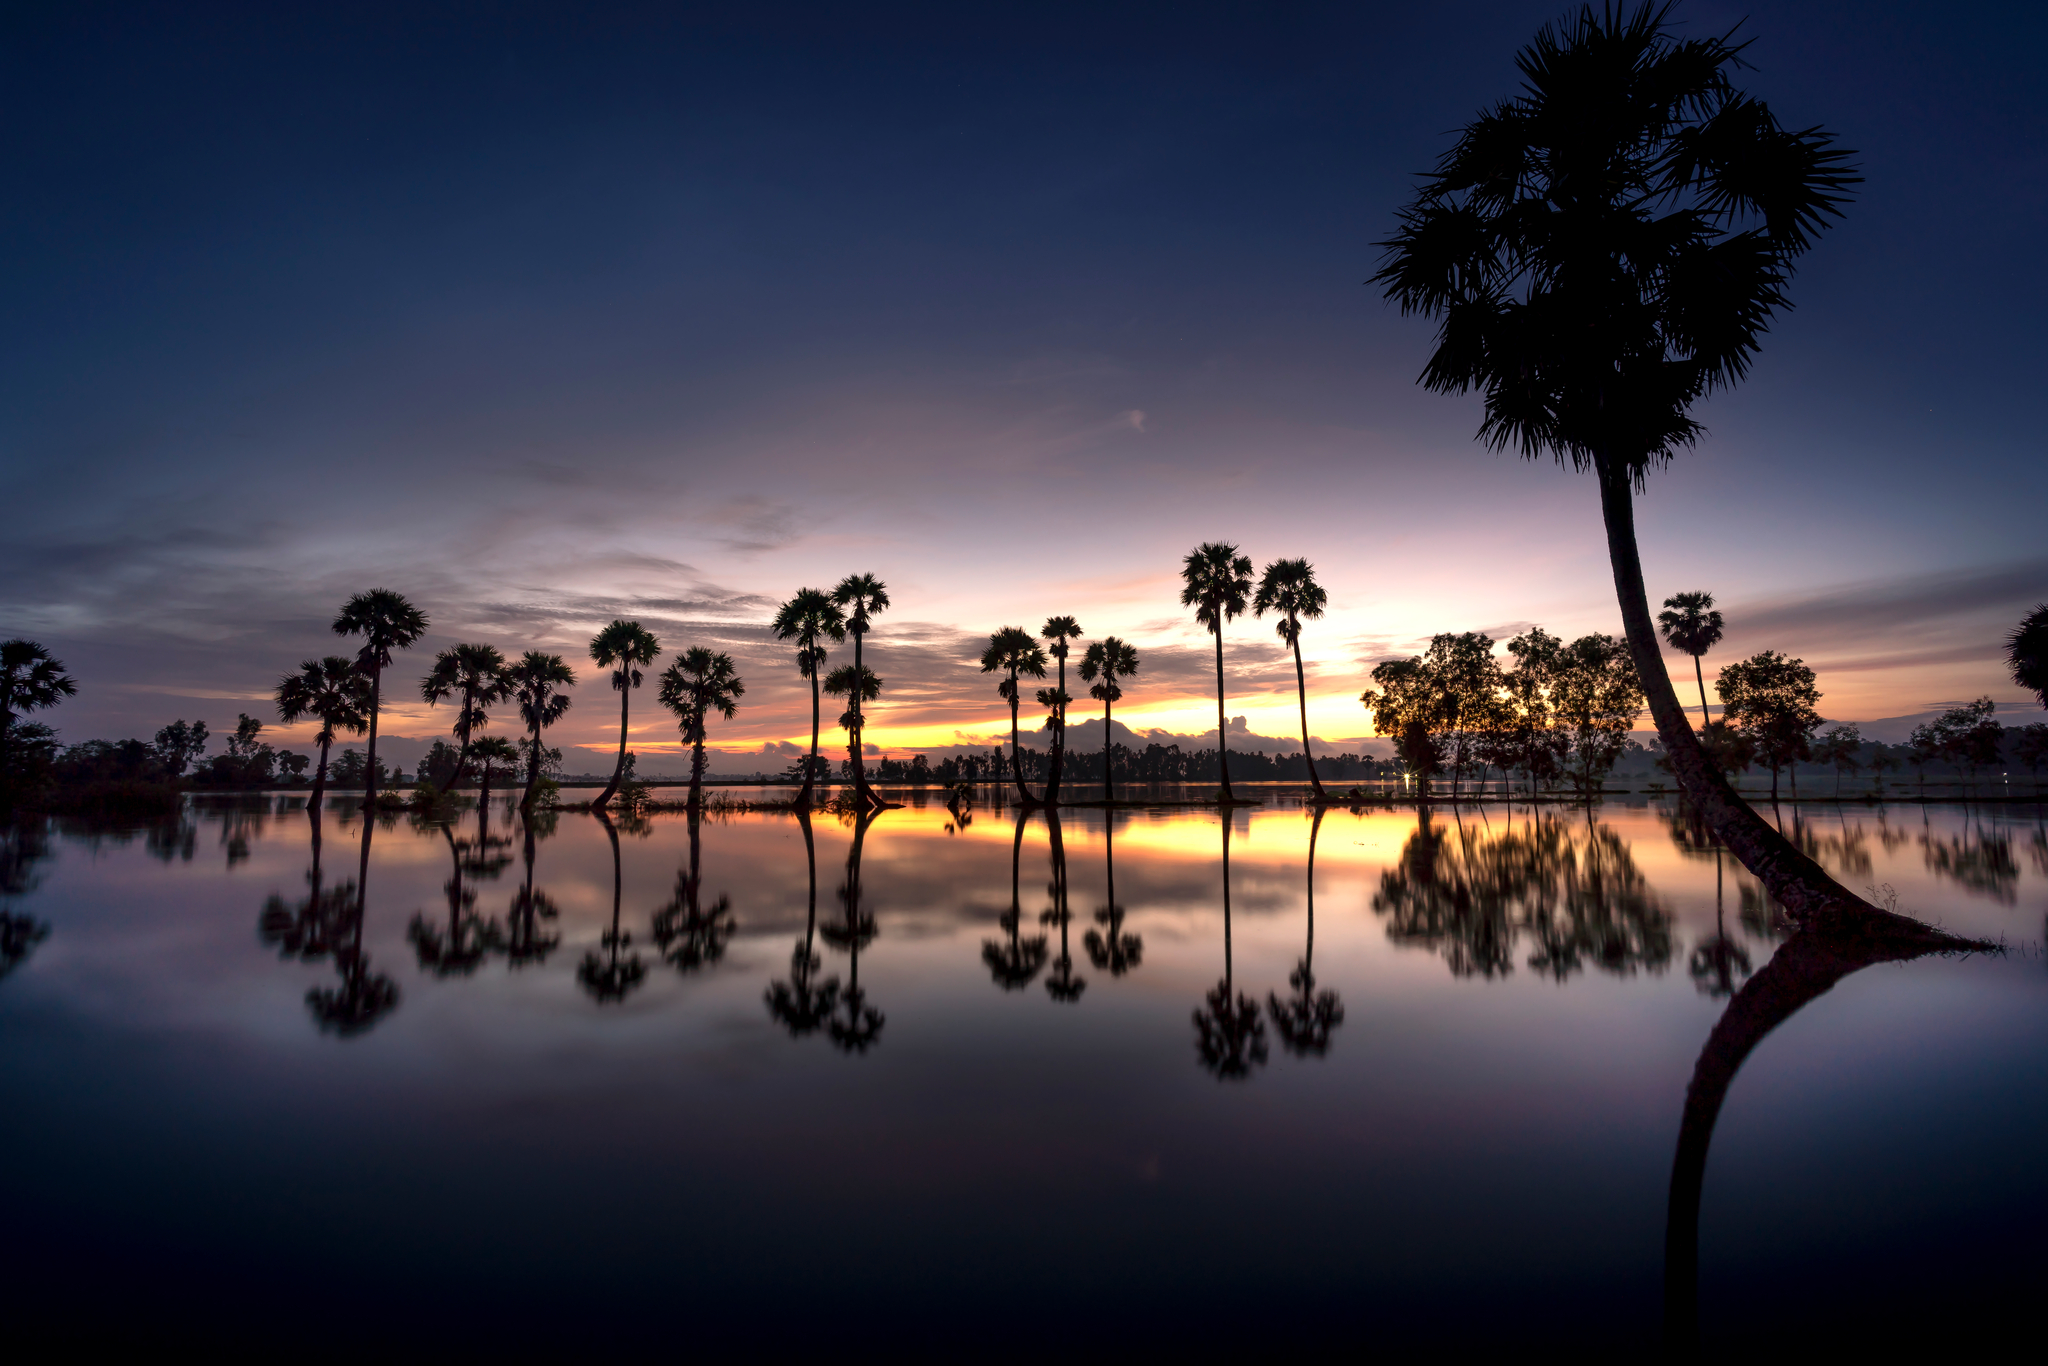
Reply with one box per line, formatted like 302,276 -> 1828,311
0,0 -> 2048,772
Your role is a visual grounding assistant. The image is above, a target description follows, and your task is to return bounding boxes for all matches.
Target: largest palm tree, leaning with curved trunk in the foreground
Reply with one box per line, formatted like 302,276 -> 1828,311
1374,6 -> 1923,934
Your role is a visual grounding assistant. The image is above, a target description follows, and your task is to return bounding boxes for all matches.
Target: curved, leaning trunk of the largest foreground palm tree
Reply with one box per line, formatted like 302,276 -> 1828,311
1595,457 -> 1946,938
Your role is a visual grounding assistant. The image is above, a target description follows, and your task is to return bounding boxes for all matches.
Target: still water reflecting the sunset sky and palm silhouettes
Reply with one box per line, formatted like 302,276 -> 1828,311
0,797 -> 2048,1358
